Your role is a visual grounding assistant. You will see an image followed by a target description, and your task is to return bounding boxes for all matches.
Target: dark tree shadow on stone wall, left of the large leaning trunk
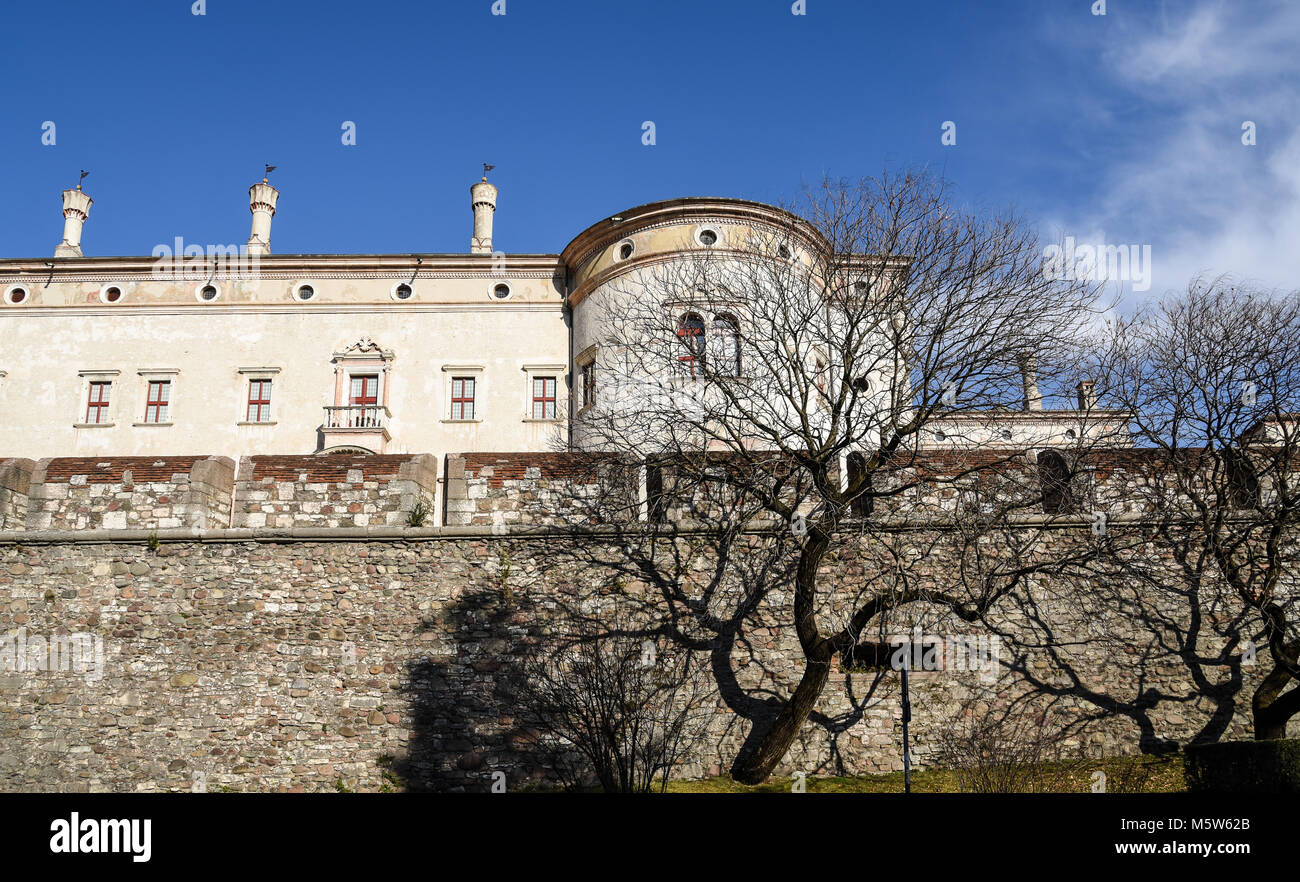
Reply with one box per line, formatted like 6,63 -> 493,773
394,533 -> 881,792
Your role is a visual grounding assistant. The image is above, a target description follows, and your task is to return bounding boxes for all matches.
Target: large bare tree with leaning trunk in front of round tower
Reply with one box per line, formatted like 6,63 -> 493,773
564,172 -> 1096,783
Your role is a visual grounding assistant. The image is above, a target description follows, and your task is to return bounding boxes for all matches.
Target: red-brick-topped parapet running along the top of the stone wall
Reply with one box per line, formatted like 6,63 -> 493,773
0,451 -> 1180,529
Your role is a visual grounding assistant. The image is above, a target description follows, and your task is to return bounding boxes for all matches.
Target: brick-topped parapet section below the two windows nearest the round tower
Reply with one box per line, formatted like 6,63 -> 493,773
446,453 -> 629,527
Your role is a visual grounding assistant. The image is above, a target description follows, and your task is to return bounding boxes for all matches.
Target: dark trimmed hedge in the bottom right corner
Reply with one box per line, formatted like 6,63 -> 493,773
1183,738 -> 1300,794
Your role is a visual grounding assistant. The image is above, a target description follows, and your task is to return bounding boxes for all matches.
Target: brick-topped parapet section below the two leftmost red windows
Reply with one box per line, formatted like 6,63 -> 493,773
26,457 -> 234,529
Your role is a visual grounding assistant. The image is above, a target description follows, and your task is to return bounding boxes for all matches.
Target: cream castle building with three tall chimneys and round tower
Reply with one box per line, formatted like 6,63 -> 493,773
0,177 -> 1128,458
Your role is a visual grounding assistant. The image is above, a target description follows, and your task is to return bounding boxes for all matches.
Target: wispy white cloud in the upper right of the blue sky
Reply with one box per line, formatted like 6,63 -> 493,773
1058,0 -> 1300,298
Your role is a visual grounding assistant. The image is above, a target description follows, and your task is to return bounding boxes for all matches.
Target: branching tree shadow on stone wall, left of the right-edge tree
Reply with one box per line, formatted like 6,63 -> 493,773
989,527 -> 1251,755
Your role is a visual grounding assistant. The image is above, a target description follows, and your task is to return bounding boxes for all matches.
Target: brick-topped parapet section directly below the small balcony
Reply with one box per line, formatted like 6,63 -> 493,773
233,454 -> 438,528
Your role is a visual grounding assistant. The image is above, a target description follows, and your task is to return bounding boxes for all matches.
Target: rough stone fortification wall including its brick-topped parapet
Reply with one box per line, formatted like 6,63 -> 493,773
0,454 -> 1294,791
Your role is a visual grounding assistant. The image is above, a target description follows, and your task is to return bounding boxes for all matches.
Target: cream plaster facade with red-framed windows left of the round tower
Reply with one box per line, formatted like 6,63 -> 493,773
0,255 -> 568,457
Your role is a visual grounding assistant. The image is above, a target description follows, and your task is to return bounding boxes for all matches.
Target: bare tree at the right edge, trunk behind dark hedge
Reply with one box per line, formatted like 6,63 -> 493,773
1099,278 -> 1300,739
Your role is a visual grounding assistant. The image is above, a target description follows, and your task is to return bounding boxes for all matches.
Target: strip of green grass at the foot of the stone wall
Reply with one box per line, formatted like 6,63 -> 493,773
668,753 -> 1187,794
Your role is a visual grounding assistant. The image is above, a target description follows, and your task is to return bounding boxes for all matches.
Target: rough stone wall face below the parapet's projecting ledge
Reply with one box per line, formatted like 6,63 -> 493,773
0,528 -> 1279,791
